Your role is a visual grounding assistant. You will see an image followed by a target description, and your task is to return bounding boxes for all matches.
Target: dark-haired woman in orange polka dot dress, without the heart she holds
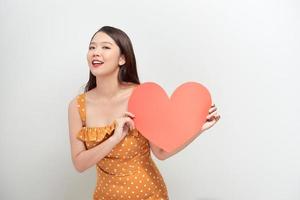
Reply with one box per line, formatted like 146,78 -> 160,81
68,26 -> 220,200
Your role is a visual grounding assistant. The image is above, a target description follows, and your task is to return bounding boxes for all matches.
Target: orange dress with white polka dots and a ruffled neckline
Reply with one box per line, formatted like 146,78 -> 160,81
77,93 -> 169,200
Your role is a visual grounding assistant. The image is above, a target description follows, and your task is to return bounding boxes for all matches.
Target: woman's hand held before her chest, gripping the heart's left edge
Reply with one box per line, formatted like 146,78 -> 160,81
111,112 -> 135,143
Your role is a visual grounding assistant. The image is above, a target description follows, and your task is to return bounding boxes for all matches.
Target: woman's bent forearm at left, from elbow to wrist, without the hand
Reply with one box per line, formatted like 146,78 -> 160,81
75,137 -> 117,172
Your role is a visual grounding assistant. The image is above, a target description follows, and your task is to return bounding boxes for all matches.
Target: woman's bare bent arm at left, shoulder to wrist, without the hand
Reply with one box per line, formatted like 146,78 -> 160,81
68,99 -> 118,172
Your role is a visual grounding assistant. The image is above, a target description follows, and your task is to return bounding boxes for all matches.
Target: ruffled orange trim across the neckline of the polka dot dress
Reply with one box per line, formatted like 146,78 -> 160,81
76,121 -> 139,142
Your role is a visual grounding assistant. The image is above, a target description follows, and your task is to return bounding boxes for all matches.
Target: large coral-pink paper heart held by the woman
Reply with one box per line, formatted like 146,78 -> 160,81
128,82 -> 211,152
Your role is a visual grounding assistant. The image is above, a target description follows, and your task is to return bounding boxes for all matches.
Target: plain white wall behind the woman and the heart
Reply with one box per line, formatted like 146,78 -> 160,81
0,0 -> 300,200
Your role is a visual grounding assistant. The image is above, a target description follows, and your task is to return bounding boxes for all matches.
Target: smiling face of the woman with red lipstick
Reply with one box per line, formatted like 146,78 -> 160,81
87,32 -> 125,76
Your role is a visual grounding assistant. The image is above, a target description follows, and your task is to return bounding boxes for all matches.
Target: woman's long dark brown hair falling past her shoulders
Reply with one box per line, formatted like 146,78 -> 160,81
84,26 -> 140,92
